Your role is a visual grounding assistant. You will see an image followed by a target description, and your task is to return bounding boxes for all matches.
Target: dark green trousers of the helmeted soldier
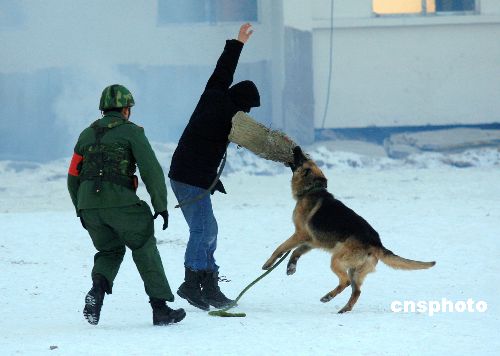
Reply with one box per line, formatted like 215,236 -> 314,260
80,201 -> 174,302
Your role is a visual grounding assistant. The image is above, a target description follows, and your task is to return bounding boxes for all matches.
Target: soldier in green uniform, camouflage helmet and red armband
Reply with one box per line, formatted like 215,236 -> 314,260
68,84 -> 186,325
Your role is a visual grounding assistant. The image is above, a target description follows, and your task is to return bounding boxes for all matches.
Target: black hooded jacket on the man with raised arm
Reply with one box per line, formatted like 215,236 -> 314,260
168,40 -> 260,193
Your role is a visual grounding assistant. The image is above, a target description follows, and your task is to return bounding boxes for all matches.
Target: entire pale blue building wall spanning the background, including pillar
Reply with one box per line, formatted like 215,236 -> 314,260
0,0 -> 500,159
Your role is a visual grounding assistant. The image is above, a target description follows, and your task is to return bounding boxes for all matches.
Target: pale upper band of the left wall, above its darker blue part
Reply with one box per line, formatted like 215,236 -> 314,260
0,0 -> 274,72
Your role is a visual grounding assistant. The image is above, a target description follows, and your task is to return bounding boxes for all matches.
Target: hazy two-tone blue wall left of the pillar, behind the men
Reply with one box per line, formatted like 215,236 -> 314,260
0,0 -> 284,160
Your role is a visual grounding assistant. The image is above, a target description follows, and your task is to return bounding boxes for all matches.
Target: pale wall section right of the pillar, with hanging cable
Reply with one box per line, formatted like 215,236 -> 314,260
311,0 -> 500,128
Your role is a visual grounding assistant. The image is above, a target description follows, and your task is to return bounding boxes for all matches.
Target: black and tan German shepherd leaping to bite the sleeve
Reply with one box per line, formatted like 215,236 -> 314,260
262,146 -> 436,313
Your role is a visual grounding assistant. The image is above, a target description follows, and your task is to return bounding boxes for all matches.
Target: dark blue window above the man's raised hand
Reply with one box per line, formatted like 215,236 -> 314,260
158,0 -> 257,24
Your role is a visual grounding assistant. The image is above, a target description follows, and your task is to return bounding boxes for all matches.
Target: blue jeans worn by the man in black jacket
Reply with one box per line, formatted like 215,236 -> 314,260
170,179 -> 219,272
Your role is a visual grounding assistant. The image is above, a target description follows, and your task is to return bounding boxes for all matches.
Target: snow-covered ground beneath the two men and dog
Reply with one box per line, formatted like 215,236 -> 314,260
0,145 -> 500,355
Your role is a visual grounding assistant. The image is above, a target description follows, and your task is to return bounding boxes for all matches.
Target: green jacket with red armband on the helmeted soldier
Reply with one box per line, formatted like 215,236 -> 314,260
68,112 -> 167,216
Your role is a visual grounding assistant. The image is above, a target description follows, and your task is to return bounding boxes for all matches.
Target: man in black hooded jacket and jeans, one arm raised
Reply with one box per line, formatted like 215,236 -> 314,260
168,23 -> 260,310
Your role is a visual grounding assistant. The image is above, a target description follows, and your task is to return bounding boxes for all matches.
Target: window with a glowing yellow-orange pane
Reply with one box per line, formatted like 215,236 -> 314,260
372,0 -> 476,15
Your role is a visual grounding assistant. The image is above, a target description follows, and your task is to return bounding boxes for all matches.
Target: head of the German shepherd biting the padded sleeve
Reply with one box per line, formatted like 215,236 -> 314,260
289,146 -> 327,198
